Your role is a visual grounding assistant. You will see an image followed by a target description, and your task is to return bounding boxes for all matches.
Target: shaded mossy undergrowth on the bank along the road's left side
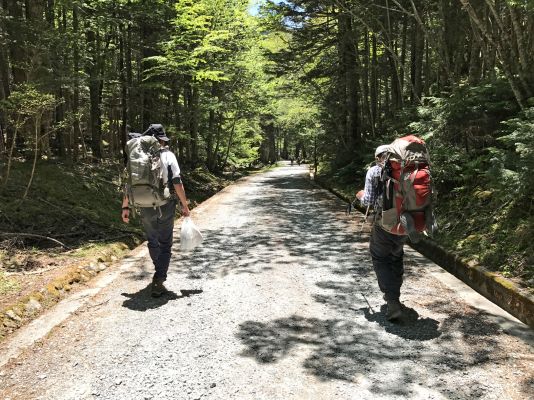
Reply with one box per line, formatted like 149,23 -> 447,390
0,160 -> 238,263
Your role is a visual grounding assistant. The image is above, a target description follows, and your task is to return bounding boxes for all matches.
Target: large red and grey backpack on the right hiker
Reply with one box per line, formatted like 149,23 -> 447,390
381,135 -> 432,235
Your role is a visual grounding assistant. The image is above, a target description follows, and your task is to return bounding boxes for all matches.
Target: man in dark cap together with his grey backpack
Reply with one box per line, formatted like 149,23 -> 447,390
122,124 -> 190,297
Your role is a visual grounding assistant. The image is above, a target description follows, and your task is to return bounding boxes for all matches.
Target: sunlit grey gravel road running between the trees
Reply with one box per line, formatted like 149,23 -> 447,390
0,166 -> 534,400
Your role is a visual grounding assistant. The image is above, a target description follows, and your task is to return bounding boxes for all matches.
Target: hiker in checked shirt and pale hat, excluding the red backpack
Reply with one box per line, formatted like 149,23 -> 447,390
356,145 -> 406,321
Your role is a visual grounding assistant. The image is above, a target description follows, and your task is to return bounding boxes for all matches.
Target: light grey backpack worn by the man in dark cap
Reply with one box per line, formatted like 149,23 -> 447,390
126,136 -> 168,208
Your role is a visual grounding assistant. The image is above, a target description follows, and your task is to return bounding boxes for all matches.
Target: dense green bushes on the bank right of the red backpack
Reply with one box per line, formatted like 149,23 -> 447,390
404,81 -> 534,281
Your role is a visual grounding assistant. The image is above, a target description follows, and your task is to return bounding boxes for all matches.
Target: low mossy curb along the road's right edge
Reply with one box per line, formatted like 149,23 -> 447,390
312,178 -> 534,329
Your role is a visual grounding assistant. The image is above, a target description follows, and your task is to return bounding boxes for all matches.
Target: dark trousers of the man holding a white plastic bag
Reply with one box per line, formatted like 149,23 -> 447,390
141,200 -> 176,281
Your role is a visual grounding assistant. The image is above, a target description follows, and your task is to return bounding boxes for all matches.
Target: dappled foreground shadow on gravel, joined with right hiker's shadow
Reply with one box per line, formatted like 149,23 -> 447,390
236,308 -> 506,398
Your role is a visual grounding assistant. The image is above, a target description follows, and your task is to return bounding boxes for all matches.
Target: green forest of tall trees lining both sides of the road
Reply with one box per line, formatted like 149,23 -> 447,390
0,0 -> 534,288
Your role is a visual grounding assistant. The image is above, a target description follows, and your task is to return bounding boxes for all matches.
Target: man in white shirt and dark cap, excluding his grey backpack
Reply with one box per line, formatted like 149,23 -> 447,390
122,124 -> 190,297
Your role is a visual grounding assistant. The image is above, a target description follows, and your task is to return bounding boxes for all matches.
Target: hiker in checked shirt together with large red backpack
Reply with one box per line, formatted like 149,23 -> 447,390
356,136 -> 435,321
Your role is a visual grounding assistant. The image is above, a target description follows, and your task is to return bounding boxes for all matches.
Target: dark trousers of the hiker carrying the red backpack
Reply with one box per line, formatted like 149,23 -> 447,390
369,224 -> 406,300
